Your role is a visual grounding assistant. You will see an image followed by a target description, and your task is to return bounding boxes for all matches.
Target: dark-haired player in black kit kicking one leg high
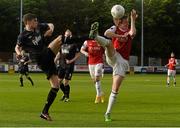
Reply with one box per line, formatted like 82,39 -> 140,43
15,13 -> 62,121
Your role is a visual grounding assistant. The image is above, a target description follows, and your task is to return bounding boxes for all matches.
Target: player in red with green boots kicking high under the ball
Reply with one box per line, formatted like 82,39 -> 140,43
89,10 -> 137,122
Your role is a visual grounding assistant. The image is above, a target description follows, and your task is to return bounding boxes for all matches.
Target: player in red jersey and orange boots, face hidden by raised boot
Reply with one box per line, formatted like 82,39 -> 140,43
81,40 -> 104,104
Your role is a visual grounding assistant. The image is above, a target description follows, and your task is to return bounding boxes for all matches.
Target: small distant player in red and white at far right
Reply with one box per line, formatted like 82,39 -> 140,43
165,52 -> 177,86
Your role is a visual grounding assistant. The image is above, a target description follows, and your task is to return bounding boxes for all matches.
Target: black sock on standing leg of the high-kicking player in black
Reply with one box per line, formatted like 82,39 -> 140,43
42,88 -> 59,114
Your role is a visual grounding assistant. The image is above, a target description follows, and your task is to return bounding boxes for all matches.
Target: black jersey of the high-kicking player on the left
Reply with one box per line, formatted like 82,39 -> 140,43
17,23 -> 49,58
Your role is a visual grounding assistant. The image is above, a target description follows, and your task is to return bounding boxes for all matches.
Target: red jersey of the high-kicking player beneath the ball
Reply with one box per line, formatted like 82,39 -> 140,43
112,27 -> 132,60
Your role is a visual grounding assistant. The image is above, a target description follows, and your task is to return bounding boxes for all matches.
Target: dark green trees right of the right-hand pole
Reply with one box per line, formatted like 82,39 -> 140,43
144,0 -> 180,57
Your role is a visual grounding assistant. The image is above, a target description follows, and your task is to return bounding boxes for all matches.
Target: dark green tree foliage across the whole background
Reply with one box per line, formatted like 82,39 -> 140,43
0,0 -> 180,57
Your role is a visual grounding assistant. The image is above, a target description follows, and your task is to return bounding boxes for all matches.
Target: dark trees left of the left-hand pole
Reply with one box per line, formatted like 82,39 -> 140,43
0,0 -> 19,51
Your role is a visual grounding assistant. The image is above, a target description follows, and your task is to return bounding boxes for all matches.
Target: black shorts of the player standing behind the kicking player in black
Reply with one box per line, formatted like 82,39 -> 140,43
58,64 -> 74,80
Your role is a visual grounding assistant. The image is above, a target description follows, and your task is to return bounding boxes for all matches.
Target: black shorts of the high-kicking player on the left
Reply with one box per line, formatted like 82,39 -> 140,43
37,48 -> 57,79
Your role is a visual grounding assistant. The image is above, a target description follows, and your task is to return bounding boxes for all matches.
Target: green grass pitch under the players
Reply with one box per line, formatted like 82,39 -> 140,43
0,73 -> 180,127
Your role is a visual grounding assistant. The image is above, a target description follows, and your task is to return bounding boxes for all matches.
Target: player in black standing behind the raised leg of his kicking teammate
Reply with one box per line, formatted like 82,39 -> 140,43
55,29 -> 80,102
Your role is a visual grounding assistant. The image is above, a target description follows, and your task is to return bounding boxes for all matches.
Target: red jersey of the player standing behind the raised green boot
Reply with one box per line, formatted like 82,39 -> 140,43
83,40 -> 104,64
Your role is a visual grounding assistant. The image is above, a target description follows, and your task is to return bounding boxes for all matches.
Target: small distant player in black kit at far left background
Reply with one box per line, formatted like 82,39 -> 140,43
18,50 -> 34,87
